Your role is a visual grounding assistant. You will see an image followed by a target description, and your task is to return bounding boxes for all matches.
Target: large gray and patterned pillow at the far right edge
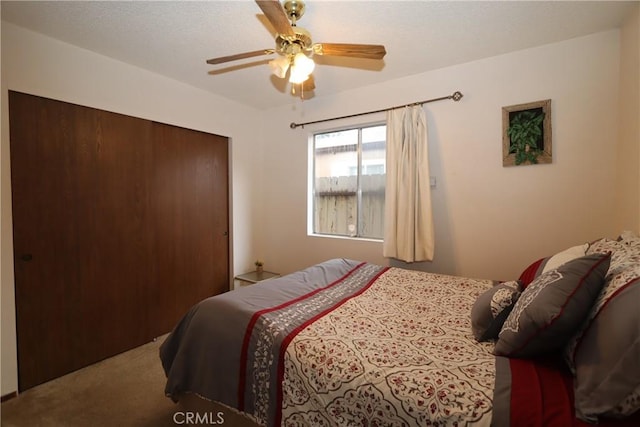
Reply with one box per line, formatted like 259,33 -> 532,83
565,238 -> 640,422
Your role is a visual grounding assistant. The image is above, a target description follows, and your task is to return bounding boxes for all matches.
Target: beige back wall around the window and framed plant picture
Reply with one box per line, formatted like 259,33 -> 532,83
260,31 -> 638,279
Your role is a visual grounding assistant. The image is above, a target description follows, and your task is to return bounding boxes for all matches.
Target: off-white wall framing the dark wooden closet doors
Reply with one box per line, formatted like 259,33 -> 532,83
0,22 -> 260,395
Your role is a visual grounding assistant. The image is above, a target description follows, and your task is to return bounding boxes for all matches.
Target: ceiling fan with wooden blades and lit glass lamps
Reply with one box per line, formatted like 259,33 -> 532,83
207,0 -> 387,93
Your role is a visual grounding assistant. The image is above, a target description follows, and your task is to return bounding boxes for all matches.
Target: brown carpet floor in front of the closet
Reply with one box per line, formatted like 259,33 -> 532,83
1,337 -> 256,427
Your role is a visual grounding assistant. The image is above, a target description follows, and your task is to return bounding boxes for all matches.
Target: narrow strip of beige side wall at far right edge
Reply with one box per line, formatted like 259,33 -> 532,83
616,4 -> 640,233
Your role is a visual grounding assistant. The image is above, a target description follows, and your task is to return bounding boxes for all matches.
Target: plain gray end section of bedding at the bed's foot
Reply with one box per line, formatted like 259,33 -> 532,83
160,259 -> 360,408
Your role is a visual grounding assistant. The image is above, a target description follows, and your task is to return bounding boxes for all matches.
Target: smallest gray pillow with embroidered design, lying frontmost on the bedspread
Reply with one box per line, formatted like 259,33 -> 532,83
471,280 -> 521,341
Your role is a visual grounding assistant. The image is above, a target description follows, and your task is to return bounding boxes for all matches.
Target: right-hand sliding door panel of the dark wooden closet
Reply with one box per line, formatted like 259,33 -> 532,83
149,123 -> 230,333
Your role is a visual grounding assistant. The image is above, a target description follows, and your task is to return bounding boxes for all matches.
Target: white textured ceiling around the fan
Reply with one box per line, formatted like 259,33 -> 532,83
1,0 -> 638,108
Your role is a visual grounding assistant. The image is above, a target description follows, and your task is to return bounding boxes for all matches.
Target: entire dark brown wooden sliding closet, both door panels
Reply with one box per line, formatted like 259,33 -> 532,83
9,92 -> 230,391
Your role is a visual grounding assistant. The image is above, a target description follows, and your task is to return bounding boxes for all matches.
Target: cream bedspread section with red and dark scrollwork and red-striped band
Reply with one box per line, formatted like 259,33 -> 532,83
243,264 -> 495,426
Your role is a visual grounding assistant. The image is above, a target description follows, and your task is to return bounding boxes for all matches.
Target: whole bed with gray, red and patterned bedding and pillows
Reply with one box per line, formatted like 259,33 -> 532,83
160,235 -> 640,426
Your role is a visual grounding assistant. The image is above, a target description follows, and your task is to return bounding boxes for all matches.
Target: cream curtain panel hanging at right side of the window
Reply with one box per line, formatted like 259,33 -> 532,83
383,106 -> 434,262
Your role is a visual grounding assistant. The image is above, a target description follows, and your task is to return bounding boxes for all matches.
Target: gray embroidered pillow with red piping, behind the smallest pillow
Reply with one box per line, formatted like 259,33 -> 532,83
495,253 -> 611,357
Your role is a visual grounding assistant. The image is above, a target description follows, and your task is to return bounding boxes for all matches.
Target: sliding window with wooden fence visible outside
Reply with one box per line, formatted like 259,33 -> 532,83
311,125 -> 387,239
